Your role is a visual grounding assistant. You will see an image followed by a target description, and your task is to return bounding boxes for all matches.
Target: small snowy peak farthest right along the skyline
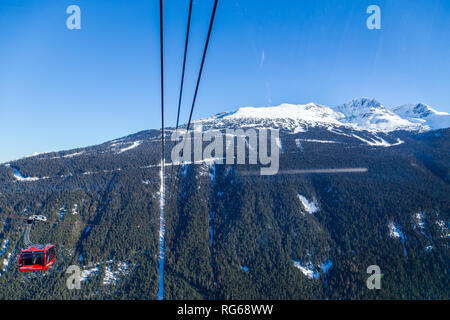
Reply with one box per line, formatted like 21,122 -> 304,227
392,103 -> 450,130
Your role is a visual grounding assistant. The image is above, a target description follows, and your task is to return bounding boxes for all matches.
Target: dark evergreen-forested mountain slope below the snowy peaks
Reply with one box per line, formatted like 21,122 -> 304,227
0,100 -> 450,299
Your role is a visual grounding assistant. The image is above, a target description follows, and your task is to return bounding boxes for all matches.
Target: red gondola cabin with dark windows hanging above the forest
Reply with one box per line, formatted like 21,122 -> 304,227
19,244 -> 56,272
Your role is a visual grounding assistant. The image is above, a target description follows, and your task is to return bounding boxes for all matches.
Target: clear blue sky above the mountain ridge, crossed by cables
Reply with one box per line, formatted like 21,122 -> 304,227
0,0 -> 450,162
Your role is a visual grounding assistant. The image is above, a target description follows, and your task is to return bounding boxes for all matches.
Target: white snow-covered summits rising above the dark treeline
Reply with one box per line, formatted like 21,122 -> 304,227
196,98 -> 450,133
